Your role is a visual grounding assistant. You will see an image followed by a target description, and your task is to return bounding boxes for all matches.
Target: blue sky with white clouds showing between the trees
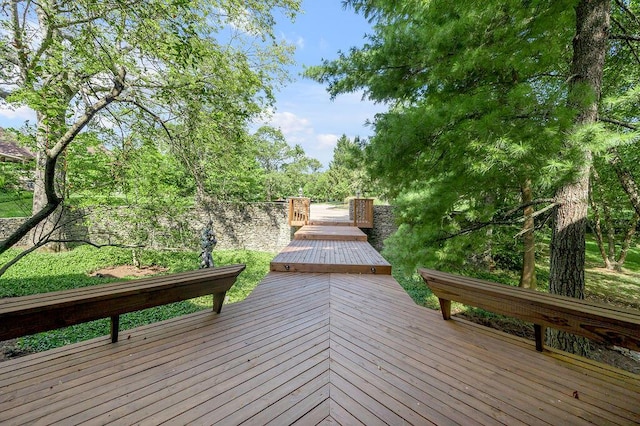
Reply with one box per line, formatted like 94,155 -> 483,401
0,0 -> 384,166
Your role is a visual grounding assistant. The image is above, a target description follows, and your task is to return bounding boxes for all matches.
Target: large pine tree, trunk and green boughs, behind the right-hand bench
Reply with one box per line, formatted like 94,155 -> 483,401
308,0 -> 640,353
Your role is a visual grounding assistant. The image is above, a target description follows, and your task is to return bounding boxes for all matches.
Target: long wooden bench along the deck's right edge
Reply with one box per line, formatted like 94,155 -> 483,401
418,269 -> 640,351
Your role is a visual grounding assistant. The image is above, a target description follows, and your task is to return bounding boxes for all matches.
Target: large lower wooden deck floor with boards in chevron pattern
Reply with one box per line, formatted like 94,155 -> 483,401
0,225 -> 640,425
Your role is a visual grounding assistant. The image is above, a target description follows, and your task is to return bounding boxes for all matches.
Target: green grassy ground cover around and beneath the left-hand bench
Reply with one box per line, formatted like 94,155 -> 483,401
0,246 -> 273,351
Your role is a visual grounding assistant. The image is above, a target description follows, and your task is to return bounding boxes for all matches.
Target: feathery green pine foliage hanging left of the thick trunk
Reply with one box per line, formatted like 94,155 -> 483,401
308,1 -> 575,267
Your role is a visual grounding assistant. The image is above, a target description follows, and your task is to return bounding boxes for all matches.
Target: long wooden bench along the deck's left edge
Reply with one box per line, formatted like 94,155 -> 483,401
0,265 -> 245,343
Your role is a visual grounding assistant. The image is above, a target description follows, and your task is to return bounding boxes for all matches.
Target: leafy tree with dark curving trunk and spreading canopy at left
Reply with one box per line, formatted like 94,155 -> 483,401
0,0 -> 299,270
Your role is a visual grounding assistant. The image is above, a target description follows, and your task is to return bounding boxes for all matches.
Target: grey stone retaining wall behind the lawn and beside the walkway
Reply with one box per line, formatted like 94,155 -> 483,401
0,203 -> 397,253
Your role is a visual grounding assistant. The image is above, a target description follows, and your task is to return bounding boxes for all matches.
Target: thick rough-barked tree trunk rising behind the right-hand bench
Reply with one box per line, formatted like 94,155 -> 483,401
547,0 -> 611,355
